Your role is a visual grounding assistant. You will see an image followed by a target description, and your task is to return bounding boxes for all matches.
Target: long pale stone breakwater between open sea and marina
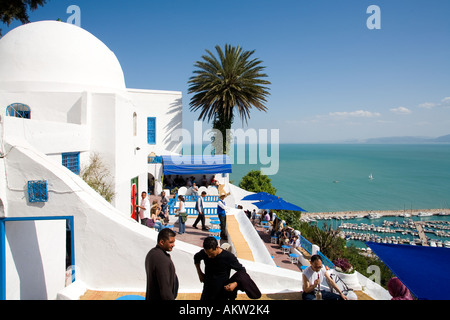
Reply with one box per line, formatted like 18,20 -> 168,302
302,209 -> 450,218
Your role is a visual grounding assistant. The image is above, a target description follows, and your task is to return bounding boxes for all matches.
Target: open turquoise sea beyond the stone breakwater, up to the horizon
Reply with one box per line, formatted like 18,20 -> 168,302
230,144 -> 450,212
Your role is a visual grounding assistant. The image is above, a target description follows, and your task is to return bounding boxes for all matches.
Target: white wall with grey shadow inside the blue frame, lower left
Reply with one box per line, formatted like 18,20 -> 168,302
5,220 -> 66,300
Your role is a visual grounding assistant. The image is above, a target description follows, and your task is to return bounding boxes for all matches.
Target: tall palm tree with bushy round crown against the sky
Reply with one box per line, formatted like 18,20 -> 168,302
188,44 -> 270,152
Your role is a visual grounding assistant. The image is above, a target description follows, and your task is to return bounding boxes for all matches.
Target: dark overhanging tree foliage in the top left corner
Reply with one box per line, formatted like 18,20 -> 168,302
0,0 -> 47,37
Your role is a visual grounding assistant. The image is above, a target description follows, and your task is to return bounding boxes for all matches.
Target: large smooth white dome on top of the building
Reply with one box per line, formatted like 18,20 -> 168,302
0,21 -> 125,90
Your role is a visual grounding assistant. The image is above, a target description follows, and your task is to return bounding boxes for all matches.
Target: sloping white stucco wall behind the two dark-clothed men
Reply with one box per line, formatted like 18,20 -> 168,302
0,136 -> 301,298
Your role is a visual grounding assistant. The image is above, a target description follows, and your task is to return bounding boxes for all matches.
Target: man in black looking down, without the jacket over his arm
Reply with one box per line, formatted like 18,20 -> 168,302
194,237 -> 245,300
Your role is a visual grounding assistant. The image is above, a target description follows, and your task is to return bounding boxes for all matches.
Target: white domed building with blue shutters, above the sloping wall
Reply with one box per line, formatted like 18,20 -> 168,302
0,21 -> 182,218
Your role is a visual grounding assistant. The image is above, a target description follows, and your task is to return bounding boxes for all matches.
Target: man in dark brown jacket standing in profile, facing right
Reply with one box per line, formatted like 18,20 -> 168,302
145,228 -> 178,300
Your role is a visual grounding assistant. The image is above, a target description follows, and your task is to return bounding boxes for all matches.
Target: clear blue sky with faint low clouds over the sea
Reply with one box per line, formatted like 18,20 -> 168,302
1,0 -> 450,143
